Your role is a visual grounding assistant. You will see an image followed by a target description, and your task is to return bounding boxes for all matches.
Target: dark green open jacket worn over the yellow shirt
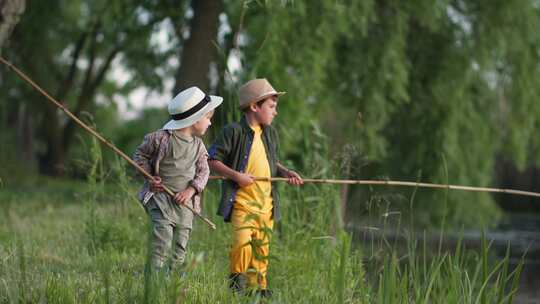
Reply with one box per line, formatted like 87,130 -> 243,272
208,117 -> 280,222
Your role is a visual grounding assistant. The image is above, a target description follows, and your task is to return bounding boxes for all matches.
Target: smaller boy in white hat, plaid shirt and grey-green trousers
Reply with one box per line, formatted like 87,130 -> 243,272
133,87 -> 223,270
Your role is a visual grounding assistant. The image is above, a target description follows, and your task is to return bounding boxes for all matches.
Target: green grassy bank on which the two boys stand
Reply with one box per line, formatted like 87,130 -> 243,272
0,170 -> 519,303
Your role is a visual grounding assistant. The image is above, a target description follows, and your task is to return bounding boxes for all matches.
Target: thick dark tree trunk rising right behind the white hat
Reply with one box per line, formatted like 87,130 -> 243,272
173,0 -> 223,92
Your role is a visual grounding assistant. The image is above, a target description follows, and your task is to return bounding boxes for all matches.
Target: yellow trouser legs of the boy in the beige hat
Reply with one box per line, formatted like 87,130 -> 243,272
229,205 -> 274,289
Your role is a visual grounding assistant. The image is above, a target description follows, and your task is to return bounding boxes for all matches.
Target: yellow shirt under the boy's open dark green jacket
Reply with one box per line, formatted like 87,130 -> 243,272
235,126 -> 272,214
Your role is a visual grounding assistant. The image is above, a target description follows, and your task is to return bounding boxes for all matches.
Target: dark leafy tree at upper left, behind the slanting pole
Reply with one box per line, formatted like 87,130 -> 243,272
1,1 -> 173,175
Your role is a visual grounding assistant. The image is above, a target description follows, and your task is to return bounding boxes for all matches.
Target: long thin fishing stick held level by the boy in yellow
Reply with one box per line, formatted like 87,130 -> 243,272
210,176 -> 540,197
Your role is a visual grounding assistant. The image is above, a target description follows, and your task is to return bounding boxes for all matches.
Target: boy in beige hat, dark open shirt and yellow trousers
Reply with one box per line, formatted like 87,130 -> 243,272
209,79 -> 303,297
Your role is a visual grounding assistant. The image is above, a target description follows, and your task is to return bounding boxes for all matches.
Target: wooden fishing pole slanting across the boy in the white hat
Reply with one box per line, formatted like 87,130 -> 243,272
0,57 -> 216,230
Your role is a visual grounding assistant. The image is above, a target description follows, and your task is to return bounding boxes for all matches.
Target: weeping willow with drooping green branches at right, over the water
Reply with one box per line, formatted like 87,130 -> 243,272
230,1 -> 540,223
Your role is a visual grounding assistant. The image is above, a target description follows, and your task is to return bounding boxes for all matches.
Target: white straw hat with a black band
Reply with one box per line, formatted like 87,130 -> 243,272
163,87 -> 223,130
